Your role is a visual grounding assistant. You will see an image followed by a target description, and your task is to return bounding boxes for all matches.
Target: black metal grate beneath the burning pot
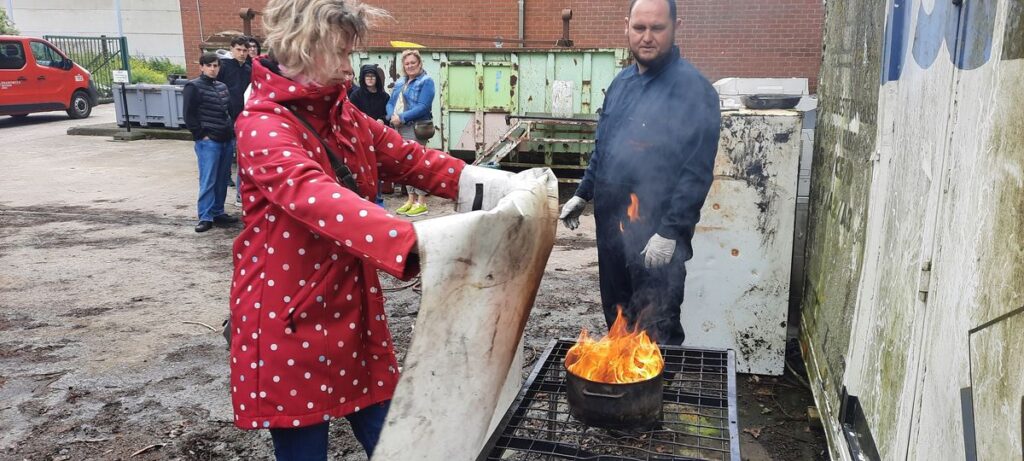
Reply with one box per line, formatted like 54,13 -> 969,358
477,339 -> 739,461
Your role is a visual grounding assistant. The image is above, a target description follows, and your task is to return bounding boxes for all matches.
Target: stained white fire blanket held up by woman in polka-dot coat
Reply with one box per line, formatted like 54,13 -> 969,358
374,169 -> 558,461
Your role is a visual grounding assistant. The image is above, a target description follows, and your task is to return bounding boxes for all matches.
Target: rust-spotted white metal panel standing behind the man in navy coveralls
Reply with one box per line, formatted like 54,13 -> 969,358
682,111 -> 801,375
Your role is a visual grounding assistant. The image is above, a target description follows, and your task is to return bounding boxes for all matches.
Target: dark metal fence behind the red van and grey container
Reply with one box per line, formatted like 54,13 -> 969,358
43,35 -> 131,102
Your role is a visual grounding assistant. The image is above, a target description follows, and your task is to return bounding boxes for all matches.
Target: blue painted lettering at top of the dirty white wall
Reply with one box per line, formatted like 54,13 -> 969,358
882,0 -> 998,83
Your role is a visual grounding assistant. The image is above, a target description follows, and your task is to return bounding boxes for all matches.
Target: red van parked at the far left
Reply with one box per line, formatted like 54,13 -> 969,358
0,35 -> 98,119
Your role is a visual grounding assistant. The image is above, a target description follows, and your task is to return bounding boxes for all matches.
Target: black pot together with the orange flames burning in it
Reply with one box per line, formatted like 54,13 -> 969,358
565,308 -> 665,430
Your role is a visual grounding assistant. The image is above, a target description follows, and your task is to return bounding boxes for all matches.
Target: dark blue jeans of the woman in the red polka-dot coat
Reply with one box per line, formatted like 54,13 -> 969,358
270,401 -> 391,461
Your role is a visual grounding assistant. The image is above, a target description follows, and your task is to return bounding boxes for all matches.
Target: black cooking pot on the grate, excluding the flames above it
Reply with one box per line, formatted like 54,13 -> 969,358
565,369 -> 665,430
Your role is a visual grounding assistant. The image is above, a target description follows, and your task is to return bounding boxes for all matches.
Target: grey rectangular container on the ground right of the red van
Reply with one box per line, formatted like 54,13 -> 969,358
114,84 -> 185,129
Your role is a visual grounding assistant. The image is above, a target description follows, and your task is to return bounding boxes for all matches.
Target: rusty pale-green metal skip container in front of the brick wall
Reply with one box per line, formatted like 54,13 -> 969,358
352,48 -> 629,159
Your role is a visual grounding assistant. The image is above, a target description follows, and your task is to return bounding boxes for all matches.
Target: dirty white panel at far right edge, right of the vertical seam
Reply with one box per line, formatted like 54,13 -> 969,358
909,1 -> 1024,460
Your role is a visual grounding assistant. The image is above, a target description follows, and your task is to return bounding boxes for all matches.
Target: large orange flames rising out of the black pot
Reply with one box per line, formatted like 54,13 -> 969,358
565,306 -> 665,384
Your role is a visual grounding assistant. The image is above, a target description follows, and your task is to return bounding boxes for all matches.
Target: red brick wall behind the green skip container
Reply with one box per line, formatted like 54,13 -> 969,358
181,0 -> 824,91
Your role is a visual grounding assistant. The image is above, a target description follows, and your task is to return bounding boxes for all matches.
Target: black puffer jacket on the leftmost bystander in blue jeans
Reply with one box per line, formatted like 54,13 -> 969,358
181,75 -> 234,142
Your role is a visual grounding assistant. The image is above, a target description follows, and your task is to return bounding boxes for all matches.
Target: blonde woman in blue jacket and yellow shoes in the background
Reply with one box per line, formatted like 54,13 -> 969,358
387,49 -> 435,216
